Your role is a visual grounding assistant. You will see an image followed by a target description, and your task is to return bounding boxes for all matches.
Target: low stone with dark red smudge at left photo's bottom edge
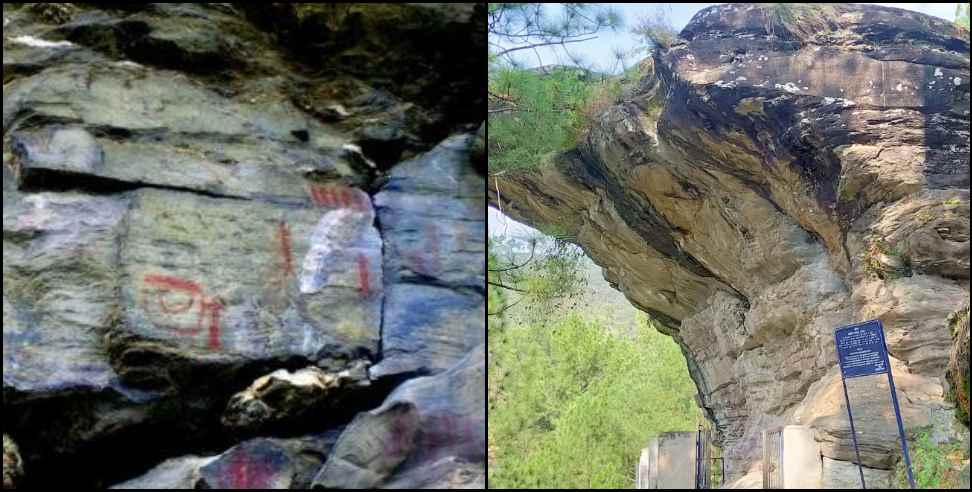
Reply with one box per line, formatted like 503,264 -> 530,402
111,432 -> 338,490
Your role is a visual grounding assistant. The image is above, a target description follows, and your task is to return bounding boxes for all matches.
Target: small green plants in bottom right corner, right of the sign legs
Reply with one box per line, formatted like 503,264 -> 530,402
894,430 -> 969,489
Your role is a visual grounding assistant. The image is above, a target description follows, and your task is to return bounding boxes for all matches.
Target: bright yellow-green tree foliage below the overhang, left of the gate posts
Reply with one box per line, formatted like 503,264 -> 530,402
489,316 -> 700,488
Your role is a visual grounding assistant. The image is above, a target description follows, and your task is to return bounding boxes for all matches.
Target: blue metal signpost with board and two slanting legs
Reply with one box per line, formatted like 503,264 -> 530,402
834,320 -> 915,488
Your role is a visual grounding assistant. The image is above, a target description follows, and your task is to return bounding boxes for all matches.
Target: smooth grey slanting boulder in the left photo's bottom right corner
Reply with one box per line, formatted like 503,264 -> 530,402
314,345 -> 486,488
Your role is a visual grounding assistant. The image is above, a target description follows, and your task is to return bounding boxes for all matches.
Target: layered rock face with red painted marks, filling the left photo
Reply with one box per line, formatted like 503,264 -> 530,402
2,4 -> 485,488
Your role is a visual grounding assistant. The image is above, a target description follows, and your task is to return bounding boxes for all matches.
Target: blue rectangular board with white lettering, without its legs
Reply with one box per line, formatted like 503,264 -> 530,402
834,320 -> 888,378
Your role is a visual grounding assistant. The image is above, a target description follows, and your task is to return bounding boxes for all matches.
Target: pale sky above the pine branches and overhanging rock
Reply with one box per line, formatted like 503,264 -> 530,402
489,3 -> 958,241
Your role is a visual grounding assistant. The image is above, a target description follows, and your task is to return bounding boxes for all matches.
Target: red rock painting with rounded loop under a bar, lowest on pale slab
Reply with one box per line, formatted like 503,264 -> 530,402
144,275 -> 223,349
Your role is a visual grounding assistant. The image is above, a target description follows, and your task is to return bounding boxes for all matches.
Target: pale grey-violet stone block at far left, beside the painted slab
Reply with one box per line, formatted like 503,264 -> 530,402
3,192 -> 128,394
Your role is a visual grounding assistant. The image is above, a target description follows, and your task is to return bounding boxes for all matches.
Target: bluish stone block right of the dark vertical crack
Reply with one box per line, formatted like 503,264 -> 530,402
371,136 -> 486,379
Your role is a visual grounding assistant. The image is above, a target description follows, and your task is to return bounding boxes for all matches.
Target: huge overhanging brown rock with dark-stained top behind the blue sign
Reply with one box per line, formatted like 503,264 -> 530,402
488,4 -> 969,483
